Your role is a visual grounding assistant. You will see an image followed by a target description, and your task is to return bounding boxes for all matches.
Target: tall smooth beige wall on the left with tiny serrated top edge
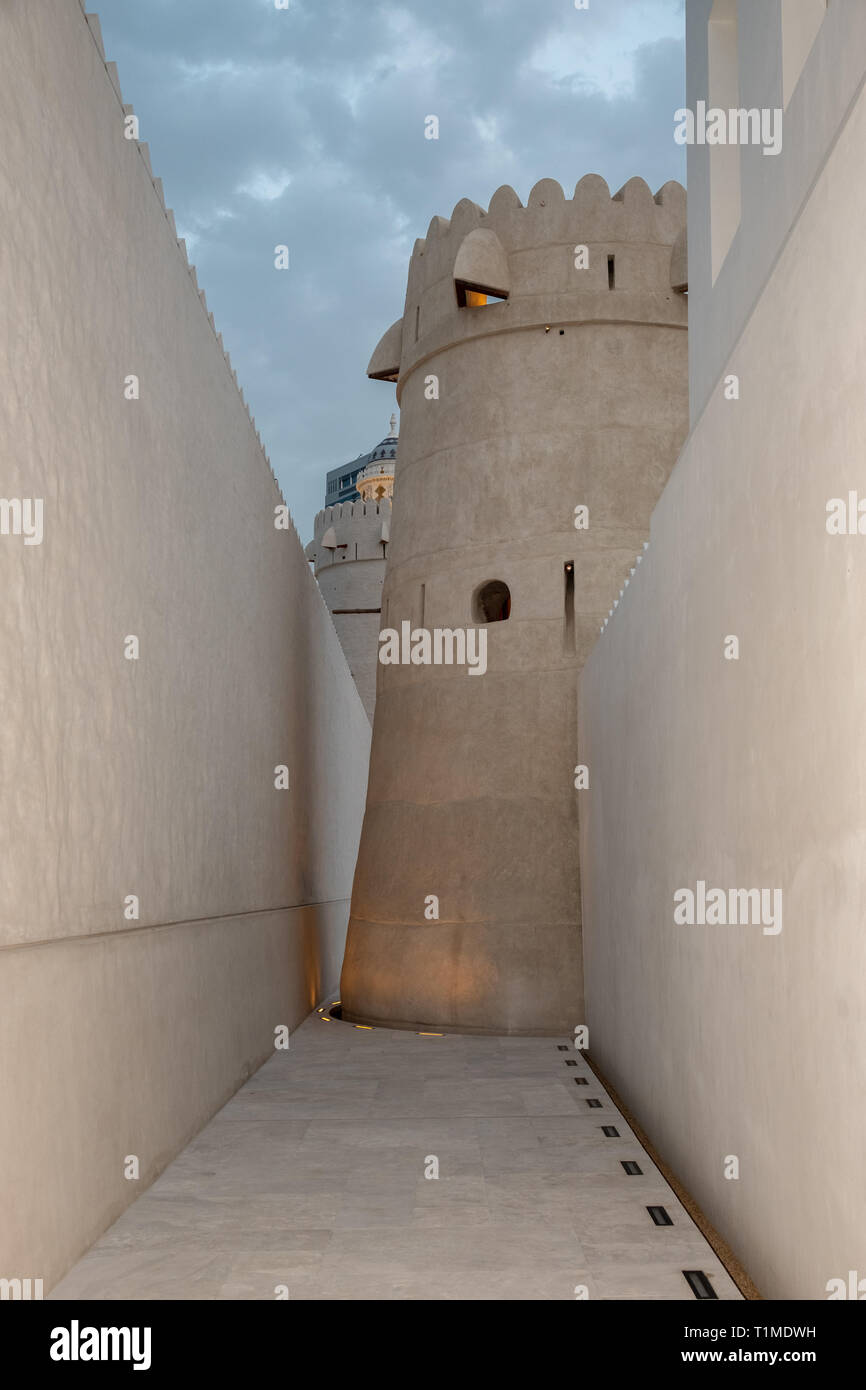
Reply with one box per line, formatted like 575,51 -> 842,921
0,0 -> 370,1291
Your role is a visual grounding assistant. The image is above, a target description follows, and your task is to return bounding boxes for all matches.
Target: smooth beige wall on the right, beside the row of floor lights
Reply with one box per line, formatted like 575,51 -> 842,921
580,67 -> 866,1298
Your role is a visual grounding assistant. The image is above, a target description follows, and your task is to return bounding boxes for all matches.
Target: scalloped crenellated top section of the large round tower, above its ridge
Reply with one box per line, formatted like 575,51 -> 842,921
367,174 -> 687,381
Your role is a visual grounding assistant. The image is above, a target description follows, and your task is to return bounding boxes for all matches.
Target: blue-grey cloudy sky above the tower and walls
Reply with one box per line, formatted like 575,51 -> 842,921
90,0 -> 685,539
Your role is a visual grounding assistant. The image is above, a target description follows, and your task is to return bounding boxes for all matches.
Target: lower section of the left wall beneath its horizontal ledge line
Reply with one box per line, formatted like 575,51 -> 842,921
0,902 -> 346,1290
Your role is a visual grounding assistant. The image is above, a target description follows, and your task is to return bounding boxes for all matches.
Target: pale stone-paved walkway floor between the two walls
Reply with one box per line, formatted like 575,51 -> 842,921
51,1015 -> 741,1301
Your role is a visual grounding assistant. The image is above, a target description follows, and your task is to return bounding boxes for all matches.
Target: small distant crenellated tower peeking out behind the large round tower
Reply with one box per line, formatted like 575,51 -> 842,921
304,416 -> 398,720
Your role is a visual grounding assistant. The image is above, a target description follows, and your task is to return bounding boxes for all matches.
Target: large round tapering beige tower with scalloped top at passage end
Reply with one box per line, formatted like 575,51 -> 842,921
341,175 -> 688,1033
